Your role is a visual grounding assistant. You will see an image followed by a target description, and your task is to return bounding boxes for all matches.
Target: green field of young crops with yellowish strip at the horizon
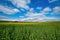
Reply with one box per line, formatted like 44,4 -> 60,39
0,22 -> 60,40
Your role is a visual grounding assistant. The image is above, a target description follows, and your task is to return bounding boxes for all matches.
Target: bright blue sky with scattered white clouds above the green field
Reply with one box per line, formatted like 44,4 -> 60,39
0,0 -> 60,22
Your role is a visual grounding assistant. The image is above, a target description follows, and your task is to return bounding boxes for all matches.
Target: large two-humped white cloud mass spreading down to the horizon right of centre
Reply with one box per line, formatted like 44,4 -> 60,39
20,7 -> 60,22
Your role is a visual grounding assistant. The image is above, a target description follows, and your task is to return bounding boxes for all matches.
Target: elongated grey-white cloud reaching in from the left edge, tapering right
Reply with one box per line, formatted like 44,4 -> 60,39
0,5 -> 19,14
